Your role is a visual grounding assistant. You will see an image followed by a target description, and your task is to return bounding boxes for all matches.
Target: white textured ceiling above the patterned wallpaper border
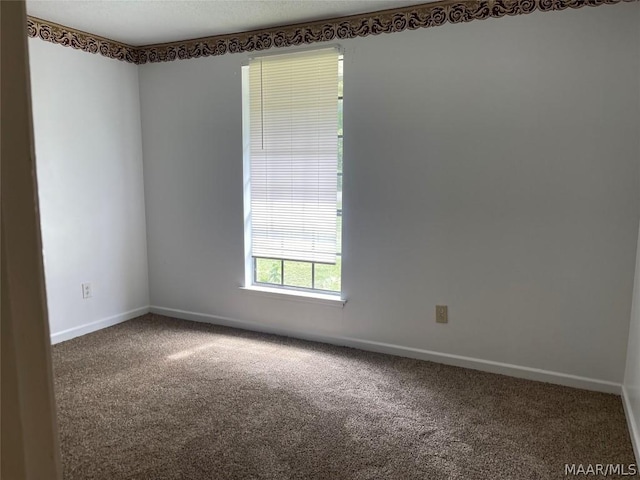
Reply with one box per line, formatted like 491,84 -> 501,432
27,0 -> 428,45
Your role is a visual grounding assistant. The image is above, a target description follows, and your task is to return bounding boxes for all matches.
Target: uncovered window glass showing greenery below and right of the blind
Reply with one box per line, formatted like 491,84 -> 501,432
253,57 -> 343,292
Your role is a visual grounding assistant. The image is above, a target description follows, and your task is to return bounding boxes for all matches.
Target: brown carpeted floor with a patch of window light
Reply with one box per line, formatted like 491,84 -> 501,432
53,315 -> 634,480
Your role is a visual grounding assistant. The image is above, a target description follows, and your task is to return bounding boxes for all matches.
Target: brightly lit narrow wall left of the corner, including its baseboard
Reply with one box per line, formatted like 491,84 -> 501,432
29,38 -> 149,341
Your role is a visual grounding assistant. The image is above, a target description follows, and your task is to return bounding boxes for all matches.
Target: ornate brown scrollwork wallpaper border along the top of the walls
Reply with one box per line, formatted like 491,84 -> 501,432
27,0 -> 639,65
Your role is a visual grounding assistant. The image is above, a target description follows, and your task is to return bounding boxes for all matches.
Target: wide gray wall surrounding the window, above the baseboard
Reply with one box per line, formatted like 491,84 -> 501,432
140,4 -> 640,383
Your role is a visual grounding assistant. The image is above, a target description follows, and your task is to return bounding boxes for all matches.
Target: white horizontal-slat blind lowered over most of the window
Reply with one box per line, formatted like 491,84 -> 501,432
249,48 -> 339,263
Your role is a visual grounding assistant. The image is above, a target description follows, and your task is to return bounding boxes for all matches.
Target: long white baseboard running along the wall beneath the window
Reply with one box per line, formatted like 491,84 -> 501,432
150,305 -> 621,395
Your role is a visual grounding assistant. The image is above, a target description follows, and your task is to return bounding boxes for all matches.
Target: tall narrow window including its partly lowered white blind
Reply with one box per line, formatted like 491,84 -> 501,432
243,48 -> 343,294
